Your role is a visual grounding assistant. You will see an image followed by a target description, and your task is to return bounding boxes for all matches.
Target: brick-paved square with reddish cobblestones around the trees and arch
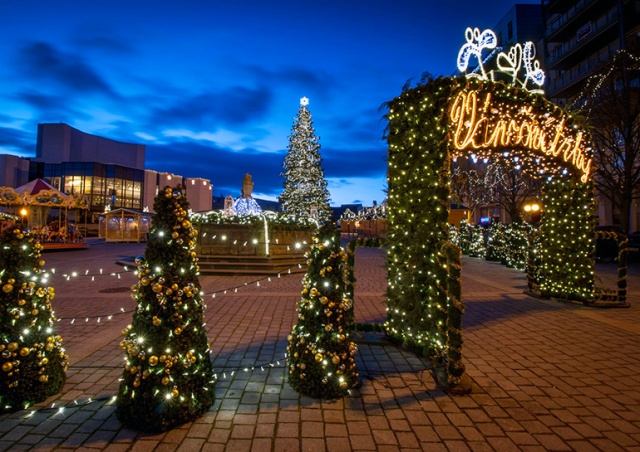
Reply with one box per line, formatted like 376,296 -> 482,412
0,238 -> 640,451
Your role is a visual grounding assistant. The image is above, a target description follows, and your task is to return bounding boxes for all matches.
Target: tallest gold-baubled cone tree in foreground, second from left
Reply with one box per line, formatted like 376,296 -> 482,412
116,186 -> 214,431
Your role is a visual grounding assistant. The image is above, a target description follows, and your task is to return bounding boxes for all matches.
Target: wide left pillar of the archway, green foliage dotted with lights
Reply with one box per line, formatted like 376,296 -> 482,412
385,79 -> 452,358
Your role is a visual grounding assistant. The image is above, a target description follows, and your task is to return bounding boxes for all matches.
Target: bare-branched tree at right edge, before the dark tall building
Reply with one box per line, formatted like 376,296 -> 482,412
577,51 -> 640,233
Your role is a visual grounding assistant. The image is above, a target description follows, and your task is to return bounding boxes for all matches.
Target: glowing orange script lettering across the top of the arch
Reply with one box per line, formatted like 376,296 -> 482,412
449,91 -> 592,183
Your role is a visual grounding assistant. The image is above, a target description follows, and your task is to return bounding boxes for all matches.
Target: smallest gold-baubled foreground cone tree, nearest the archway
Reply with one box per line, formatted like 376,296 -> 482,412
287,227 -> 358,398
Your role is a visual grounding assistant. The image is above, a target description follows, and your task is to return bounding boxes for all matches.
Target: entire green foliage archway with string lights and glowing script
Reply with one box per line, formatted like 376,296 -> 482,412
386,77 -> 594,384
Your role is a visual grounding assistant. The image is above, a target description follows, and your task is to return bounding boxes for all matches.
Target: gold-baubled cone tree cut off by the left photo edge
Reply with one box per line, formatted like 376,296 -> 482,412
0,228 -> 69,412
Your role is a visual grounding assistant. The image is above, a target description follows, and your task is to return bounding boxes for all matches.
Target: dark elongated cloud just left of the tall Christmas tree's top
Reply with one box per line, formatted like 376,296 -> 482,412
149,86 -> 273,130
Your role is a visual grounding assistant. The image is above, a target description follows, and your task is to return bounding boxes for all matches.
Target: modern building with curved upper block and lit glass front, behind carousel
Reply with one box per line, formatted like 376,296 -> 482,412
0,123 -> 212,213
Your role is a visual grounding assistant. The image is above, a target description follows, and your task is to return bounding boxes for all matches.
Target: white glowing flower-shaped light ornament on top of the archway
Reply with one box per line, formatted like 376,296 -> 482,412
457,27 -> 545,94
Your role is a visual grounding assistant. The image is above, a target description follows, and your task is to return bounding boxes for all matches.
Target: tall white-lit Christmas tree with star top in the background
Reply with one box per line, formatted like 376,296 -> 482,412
280,97 -> 331,223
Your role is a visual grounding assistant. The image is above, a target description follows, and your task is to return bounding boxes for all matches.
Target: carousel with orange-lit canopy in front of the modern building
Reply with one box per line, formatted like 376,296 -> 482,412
0,179 -> 89,250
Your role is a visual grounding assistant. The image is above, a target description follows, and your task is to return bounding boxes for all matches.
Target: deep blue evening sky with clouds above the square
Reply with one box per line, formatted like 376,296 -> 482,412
0,0 -> 539,205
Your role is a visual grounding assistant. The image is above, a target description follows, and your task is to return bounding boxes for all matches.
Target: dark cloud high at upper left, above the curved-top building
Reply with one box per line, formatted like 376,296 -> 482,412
18,42 -> 115,96
